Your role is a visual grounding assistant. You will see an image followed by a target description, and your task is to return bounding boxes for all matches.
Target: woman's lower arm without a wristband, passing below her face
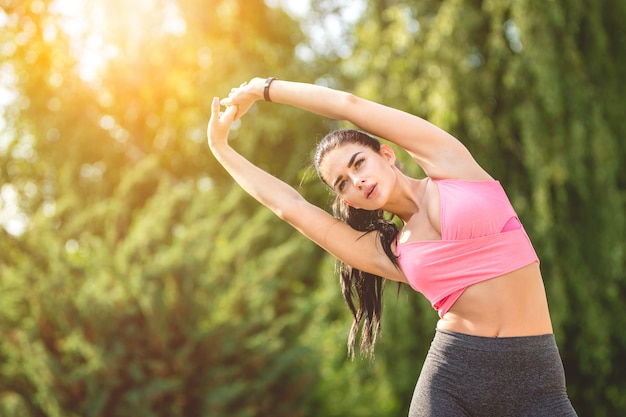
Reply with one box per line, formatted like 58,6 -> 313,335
207,98 -> 405,281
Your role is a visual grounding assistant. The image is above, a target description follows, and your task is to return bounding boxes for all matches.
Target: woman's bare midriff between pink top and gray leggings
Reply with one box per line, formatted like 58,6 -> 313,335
437,262 -> 552,337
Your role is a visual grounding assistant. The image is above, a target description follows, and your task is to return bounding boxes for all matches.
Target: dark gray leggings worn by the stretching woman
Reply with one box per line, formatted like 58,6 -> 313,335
409,330 -> 576,417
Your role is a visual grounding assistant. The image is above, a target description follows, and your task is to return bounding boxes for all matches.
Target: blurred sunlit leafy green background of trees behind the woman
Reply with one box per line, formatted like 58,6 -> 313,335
0,0 -> 626,417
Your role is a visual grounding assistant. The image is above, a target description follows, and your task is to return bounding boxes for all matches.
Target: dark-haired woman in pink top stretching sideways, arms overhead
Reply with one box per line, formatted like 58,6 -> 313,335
208,77 -> 576,417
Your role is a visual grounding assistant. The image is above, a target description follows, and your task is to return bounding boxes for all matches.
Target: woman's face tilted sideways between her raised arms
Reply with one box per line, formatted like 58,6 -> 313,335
319,143 -> 396,210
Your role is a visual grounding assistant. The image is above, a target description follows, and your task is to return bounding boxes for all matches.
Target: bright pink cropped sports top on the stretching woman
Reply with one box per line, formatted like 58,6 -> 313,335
397,180 -> 539,317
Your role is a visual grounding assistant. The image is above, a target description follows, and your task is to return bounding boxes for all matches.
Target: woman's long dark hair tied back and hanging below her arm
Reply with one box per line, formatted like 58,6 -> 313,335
313,129 -> 399,358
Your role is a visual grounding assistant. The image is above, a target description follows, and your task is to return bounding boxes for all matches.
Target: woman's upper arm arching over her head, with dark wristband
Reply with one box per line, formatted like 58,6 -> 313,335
223,78 -> 491,180
